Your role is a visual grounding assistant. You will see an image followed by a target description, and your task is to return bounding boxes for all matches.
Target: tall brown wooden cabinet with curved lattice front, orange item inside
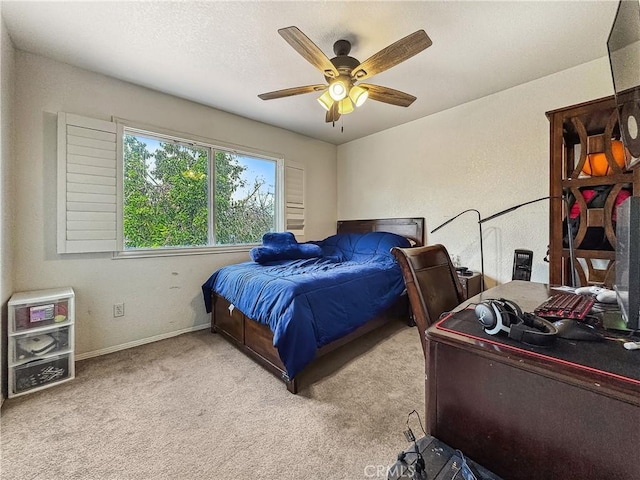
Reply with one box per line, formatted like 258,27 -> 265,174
546,96 -> 640,286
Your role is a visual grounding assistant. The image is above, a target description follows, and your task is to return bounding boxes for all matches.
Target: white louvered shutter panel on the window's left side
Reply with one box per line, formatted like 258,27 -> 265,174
58,113 -> 118,253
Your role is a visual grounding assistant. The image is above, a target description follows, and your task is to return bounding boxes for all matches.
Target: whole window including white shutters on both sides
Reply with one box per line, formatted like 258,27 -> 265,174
57,113 -> 304,256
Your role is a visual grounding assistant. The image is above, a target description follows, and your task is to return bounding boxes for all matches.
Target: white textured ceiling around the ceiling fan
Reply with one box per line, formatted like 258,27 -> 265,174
1,1 -> 617,144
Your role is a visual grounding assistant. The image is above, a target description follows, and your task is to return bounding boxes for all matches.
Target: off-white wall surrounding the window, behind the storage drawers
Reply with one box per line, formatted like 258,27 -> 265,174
12,51 -> 337,356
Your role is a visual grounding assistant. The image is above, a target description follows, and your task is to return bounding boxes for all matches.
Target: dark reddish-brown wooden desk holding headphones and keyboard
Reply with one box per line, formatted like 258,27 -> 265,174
426,281 -> 640,480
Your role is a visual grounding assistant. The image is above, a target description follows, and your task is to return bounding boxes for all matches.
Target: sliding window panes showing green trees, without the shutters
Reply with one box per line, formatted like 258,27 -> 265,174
123,127 -> 279,250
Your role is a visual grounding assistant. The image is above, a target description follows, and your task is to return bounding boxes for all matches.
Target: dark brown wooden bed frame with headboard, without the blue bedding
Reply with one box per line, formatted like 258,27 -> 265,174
211,218 -> 424,393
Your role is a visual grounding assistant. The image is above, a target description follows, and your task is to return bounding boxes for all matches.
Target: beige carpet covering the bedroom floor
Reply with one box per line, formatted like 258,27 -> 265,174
0,323 -> 424,480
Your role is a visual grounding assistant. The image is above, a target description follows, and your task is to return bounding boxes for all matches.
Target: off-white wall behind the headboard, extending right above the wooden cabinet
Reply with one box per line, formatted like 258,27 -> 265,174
338,58 -> 613,286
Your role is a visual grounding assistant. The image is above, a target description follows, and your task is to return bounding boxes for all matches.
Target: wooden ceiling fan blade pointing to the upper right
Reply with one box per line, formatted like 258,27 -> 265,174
351,30 -> 433,80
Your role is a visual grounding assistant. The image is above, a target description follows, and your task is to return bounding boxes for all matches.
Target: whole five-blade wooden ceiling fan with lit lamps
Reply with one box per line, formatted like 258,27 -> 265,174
258,27 -> 432,122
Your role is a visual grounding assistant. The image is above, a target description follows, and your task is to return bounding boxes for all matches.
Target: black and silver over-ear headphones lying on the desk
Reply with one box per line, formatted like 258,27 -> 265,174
476,298 -> 558,347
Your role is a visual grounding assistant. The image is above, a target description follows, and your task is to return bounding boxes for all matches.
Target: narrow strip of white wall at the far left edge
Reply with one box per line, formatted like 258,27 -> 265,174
0,11 -> 15,403
